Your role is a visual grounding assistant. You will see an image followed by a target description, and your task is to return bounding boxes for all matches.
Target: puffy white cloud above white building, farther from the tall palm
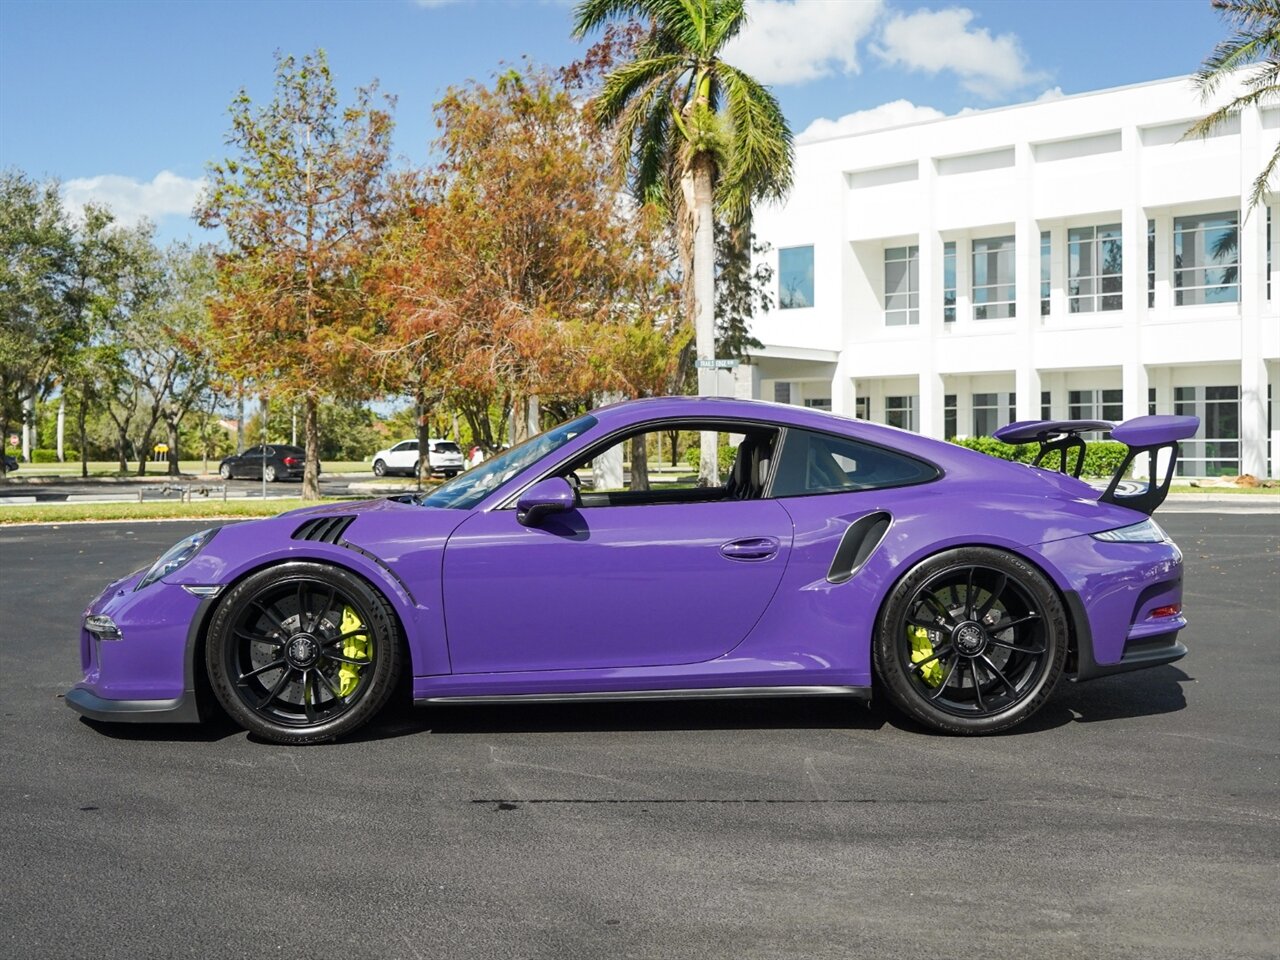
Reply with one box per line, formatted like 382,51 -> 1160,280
872,6 -> 1046,100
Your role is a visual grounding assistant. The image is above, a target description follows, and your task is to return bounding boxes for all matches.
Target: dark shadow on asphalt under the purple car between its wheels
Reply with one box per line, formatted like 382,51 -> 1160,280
343,696 -> 884,742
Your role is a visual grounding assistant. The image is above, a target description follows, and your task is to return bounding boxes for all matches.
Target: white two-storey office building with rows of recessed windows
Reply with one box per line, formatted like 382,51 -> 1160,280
736,77 -> 1280,477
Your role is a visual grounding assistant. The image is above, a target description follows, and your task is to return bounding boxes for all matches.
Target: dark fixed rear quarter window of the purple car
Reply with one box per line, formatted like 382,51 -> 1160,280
773,429 -> 938,497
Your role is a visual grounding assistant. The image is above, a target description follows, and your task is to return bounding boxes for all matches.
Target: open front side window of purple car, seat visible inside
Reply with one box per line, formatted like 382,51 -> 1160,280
559,422 -> 778,508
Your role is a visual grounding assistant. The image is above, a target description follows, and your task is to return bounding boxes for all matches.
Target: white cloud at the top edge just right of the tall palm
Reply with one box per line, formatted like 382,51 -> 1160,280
724,0 -> 883,86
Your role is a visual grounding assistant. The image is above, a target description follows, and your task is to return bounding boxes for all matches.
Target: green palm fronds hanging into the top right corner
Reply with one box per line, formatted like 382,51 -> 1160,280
1187,0 -> 1280,210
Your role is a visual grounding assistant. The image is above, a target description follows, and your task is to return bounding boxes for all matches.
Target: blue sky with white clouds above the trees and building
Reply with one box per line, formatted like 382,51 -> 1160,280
0,0 -> 1225,244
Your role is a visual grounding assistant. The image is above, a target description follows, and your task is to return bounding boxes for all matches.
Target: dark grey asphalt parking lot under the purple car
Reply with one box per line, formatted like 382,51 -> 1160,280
0,512 -> 1280,960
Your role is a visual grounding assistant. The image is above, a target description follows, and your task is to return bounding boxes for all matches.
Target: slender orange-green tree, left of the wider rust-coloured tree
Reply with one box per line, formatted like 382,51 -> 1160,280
196,51 -> 393,499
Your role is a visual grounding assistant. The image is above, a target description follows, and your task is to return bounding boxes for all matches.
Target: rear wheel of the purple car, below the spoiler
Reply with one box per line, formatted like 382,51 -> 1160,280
874,547 -> 1068,735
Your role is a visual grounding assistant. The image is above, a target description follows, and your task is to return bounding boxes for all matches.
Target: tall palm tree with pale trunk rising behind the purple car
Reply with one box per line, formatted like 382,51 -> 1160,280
573,0 -> 794,483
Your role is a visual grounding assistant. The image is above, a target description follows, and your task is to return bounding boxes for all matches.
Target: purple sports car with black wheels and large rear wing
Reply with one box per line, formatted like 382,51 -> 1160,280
67,398 -> 1198,744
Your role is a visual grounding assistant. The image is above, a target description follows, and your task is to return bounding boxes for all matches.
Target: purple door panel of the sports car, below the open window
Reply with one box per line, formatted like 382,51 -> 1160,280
443,499 -> 791,673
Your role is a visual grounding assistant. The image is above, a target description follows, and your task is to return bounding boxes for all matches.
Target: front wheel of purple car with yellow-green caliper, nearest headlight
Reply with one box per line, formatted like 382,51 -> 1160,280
205,562 -> 403,745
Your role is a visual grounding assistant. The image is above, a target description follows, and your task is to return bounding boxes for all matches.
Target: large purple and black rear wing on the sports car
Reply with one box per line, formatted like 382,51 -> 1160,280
995,416 -> 1199,516
